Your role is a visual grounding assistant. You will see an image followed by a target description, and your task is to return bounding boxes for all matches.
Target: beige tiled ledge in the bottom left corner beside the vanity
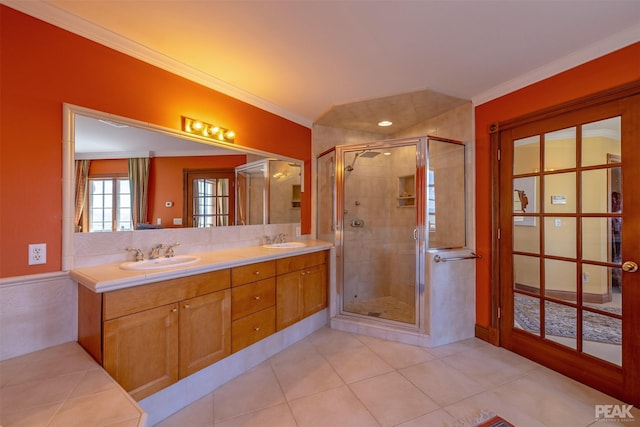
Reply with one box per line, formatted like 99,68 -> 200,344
0,342 -> 146,427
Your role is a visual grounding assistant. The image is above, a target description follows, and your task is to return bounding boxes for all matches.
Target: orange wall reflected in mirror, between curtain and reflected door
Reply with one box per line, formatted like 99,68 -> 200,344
147,155 -> 247,227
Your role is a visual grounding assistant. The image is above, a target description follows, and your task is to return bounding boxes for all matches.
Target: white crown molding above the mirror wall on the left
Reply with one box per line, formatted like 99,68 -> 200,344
0,0 -> 313,128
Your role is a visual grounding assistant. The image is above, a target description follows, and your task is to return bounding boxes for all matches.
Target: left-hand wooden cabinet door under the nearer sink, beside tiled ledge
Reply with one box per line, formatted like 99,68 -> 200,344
103,304 -> 178,400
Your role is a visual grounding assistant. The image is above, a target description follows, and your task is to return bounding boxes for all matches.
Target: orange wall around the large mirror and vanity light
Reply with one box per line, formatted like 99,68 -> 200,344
0,5 -> 312,277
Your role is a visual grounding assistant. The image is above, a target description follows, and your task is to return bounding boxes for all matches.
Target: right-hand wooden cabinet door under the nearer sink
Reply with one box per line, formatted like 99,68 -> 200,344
180,289 -> 231,378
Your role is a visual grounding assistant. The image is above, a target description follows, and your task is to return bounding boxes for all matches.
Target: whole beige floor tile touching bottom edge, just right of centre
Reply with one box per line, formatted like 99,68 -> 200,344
349,371 -> 438,427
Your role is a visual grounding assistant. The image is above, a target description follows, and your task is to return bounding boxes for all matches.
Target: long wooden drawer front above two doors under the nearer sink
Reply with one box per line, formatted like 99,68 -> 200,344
103,269 -> 231,320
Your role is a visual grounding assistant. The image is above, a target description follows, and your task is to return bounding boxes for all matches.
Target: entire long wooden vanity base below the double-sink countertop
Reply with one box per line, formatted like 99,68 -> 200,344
78,247 -> 328,400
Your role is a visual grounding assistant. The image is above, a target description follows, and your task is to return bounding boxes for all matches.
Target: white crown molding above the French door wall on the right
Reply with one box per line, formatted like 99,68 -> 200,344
471,24 -> 640,106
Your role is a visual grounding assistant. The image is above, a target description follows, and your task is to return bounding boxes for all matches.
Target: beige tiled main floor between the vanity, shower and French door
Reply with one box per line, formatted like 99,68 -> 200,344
157,328 -> 640,427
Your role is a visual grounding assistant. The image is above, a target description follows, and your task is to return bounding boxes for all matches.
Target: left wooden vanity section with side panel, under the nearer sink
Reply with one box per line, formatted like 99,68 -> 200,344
78,269 -> 231,400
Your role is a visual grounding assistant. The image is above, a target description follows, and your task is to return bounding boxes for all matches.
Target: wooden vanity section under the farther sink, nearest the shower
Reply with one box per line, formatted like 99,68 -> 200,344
276,251 -> 327,330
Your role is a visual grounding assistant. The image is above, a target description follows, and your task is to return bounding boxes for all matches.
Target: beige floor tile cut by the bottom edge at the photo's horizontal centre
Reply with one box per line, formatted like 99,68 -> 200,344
289,386 -> 379,427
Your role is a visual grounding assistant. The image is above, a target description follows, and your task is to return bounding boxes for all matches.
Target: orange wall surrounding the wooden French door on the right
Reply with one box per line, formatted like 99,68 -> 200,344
475,43 -> 640,326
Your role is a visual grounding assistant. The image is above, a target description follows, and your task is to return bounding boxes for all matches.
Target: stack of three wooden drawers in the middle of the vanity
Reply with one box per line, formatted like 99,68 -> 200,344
231,261 -> 276,353
